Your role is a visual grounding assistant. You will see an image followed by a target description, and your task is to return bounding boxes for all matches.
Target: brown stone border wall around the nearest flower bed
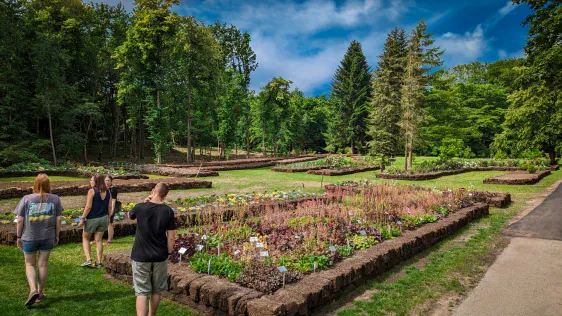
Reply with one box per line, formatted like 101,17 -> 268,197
104,203 -> 489,316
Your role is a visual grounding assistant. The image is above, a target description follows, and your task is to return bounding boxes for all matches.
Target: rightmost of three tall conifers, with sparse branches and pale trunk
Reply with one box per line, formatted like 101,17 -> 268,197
400,20 -> 443,170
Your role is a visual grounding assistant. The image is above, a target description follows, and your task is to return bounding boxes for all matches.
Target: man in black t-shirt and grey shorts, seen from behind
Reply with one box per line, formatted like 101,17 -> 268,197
129,183 -> 176,316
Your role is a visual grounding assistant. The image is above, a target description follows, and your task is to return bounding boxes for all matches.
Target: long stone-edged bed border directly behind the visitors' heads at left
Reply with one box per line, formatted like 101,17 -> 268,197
0,178 -> 212,199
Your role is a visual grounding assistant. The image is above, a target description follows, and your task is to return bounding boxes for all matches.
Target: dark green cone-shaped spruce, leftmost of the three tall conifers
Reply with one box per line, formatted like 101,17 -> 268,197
328,41 -> 373,154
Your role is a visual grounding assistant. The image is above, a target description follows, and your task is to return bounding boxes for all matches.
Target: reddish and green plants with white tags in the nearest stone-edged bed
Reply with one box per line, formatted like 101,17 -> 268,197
166,185 -> 472,293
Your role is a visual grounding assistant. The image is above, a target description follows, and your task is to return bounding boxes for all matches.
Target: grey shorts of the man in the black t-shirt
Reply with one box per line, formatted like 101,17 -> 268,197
132,260 -> 168,296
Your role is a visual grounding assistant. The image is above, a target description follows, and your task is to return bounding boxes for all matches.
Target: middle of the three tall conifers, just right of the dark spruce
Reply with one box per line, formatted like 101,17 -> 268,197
369,28 -> 408,168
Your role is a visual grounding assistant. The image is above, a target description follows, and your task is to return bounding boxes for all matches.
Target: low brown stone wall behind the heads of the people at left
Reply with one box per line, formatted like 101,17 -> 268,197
0,179 -> 213,200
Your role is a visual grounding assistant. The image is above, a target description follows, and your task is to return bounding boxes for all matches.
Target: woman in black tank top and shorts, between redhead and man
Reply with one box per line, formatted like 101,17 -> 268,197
78,174 -> 113,268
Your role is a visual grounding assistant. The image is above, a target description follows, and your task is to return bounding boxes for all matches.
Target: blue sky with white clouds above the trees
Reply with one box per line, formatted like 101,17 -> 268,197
99,0 -> 530,95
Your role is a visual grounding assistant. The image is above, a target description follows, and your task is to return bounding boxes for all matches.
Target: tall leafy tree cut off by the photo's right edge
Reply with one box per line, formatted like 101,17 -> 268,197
494,0 -> 562,164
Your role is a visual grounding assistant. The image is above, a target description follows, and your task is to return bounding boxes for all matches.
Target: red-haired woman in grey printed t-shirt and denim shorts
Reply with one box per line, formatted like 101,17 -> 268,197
15,174 -> 63,306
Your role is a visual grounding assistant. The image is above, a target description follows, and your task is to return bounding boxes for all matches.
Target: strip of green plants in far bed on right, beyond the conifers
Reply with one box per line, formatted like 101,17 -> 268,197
383,158 -> 550,174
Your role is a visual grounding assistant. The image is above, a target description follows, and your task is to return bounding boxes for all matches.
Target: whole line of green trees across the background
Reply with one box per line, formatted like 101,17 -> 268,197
0,0 -> 562,168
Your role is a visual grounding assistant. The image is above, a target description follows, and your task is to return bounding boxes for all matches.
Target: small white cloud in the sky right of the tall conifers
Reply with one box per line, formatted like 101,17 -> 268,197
436,25 -> 488,65
